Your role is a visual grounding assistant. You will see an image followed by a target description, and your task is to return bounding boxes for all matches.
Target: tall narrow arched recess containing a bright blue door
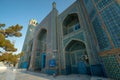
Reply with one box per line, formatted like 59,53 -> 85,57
35,28 -> 47,71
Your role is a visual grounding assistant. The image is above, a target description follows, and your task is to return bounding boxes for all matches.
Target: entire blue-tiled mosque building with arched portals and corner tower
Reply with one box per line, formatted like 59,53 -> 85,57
19,0 -> 120,80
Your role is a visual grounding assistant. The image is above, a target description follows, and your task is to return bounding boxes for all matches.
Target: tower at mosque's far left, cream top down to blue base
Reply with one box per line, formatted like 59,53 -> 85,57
19,19 -> 38,68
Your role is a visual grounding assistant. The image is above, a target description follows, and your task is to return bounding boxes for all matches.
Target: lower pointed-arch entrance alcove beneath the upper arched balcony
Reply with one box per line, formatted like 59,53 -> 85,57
65,40 -> 89,74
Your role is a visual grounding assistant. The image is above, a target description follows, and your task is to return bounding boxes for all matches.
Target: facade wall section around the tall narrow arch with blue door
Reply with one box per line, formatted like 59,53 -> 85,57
29,2 -> 58,70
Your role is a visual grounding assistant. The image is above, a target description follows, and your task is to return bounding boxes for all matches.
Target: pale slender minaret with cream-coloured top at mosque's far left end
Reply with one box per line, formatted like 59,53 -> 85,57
19,19 -> 38,68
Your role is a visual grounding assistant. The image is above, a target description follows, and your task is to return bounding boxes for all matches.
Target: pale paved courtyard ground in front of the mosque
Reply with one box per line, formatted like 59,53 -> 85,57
0,69 -> 112,80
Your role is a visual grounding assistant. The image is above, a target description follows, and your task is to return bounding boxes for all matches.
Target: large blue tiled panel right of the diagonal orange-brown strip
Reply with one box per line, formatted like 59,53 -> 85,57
101,3 -> 120,48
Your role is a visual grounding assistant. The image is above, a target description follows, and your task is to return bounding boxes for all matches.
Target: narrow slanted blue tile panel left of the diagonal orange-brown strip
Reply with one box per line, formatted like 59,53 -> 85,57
92,16 -> 111,50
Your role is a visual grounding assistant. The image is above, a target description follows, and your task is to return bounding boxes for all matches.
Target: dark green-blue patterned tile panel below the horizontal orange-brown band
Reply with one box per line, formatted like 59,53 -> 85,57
101,55 -> 120,80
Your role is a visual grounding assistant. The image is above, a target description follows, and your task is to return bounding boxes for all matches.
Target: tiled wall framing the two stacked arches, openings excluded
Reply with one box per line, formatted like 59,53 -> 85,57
58,1 -> 98,74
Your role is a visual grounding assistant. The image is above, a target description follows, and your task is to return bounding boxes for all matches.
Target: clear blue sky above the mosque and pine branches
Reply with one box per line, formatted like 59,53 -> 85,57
0,0 -> 76,54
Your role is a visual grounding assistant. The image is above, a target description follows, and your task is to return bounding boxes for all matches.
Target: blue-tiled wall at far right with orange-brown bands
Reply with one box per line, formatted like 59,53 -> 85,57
84,0 -> 120,79
